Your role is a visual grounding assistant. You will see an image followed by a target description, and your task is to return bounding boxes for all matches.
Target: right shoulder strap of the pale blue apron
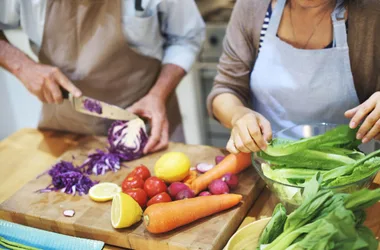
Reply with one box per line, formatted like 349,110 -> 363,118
331,0 -> 348,48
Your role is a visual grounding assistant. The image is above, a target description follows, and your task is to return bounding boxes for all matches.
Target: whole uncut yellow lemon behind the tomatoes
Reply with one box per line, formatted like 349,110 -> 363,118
154,152 -> 191,183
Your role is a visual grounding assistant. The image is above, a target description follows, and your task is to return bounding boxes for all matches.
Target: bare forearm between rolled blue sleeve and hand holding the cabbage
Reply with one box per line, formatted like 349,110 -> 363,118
149,64 -> 186,102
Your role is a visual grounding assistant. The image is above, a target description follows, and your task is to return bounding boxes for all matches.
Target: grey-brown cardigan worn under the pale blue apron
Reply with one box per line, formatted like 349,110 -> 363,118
207,0 -> 380,116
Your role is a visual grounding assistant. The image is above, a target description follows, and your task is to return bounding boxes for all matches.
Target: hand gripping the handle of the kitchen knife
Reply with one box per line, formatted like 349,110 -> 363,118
15,61 -> 82,104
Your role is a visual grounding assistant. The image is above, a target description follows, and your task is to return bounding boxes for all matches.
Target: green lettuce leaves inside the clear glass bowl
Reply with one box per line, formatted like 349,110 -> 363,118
257,125 -> 380,187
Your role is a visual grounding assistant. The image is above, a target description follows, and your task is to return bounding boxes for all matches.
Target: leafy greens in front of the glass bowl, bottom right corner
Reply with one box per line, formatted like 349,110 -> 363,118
257,176 -> 380,250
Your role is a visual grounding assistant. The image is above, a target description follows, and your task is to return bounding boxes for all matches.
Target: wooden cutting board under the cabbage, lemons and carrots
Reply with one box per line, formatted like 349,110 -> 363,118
0,137 -> 264,250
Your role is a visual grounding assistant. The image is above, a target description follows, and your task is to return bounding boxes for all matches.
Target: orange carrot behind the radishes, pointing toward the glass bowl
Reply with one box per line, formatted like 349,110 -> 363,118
190,153 -> 252,194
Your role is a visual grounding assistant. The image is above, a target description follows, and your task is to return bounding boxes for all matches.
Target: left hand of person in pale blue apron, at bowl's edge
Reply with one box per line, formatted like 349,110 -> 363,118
227,107 -> 272,154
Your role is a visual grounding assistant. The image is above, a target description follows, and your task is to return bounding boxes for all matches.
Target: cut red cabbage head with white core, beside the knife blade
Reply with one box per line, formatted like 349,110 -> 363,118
108,119 -> 148,161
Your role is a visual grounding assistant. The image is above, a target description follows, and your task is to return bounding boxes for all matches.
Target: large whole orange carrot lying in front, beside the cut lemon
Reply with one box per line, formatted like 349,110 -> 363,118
143,194 -> 242,233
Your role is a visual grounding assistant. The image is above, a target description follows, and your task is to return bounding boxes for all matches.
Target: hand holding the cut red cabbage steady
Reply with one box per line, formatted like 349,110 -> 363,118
128,94 -> 169,154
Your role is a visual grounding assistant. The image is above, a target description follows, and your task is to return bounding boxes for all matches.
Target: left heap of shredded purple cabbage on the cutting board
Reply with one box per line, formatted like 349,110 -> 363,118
37,161 -> 98,195
